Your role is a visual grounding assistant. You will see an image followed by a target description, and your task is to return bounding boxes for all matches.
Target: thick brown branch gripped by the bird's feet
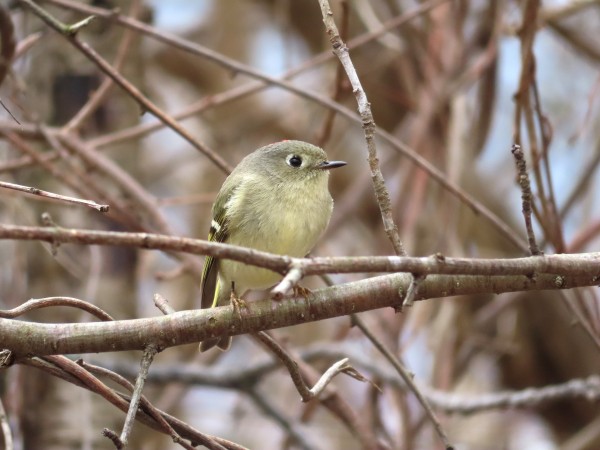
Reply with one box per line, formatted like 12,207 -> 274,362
0,266 -> 600,358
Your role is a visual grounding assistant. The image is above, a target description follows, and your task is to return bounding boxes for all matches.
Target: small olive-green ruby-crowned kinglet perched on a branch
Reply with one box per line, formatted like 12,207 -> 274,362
200,141 -> 346,351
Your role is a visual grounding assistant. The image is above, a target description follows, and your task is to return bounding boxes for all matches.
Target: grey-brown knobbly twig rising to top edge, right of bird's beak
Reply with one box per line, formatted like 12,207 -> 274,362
319,0 -> 406,256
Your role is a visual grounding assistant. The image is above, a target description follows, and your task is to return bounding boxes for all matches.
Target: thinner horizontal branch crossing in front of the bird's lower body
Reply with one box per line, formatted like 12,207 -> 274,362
0,225 -> 600,278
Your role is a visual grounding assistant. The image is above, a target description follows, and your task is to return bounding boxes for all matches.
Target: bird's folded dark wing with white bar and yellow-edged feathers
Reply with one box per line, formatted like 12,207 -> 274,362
201,186 -> 235,308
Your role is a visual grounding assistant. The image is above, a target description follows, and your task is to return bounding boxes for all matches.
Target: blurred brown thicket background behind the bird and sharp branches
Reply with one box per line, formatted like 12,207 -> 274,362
0,0 -> 600,450
